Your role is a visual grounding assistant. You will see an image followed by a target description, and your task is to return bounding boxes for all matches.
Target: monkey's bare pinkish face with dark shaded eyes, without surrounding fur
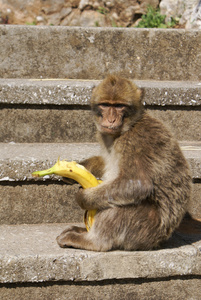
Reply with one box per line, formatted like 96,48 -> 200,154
93,102 -> 129,135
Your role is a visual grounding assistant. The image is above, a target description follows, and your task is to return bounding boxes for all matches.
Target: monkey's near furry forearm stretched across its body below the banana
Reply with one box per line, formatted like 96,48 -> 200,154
76,172 -> 153,209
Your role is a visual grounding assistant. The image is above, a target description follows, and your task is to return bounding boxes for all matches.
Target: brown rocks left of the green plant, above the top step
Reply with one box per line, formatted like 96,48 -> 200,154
0,0 -> 159,27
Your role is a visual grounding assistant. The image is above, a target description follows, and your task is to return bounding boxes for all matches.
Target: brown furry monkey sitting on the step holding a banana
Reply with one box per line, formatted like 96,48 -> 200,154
57,74 -> 192,251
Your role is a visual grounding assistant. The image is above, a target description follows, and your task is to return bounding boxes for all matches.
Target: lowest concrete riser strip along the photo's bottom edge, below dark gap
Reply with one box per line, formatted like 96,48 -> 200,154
0,276 -> 201,300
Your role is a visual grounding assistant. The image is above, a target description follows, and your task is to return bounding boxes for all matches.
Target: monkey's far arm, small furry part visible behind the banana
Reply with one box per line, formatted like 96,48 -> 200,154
80,156 -> 105,178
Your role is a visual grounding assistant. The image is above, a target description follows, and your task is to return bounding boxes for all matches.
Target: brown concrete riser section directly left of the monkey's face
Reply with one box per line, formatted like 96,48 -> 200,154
0,107 -> 95,143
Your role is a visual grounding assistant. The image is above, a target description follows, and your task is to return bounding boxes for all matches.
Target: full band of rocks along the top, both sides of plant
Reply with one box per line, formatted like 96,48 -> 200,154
0,0 -> 201,29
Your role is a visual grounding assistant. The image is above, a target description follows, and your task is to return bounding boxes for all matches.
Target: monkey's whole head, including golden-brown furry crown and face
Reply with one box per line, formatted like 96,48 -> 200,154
91,75 -> 143,136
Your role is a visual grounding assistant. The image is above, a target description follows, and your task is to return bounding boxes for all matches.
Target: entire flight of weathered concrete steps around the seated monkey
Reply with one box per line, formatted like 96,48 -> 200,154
0,25 -> 201,300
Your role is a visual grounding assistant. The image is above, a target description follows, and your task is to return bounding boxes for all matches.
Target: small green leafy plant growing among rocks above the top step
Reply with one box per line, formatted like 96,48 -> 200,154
136,6 -> 169,28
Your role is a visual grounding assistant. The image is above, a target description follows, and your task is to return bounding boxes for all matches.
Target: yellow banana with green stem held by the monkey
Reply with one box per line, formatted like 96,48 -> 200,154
32,158 -> 101,231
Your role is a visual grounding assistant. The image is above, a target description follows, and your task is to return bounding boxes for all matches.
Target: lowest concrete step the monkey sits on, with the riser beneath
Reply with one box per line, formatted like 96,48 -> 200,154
0,221 -> 201,300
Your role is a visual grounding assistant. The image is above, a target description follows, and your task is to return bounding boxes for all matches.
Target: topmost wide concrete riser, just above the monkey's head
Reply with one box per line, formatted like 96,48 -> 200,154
0,25 -> 201,81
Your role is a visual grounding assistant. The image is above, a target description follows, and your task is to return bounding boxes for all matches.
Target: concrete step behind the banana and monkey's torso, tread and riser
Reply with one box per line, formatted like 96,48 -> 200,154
0,142 -> 201,224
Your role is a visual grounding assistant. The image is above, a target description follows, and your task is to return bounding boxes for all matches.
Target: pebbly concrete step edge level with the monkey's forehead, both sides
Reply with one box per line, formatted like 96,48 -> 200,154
0,79 -> 201,107
